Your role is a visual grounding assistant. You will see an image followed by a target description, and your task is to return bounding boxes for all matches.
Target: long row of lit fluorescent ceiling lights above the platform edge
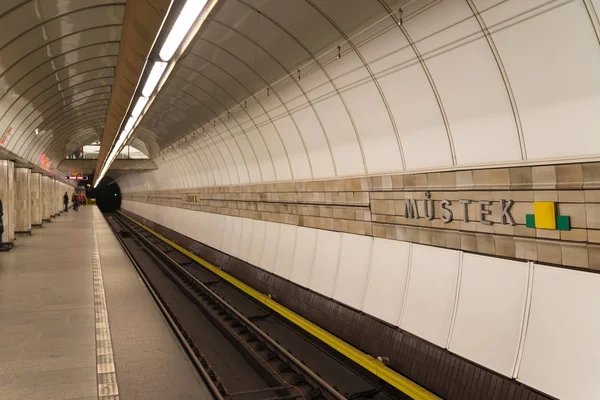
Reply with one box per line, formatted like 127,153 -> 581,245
94,0 -> 218,187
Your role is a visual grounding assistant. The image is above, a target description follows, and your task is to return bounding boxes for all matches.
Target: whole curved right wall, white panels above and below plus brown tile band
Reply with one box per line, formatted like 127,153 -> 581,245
118,0 -> 600,399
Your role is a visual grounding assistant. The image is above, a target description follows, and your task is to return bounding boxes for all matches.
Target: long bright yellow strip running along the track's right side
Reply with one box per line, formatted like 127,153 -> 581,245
119,211 -> 440,400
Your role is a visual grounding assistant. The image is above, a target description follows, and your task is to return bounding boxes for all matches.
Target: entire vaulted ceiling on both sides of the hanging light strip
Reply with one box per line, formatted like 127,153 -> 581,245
0,0 -> 600,184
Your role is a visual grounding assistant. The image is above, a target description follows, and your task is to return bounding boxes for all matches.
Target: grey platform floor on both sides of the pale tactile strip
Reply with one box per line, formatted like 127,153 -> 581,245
0,206 -> 211,400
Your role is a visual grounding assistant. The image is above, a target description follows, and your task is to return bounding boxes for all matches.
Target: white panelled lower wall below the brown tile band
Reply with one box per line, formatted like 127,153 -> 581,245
123,200 -> 600,400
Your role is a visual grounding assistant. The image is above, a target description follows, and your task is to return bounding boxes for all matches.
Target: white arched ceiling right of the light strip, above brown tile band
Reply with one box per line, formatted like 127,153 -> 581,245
118,0 -> 600,194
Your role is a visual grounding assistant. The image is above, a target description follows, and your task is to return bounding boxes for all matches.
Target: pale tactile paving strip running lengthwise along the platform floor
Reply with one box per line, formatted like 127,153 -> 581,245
92,224 -> 119,400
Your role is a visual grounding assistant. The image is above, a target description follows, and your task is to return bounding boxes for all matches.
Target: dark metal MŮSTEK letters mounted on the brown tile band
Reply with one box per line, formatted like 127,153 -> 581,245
404,192 -> 515,226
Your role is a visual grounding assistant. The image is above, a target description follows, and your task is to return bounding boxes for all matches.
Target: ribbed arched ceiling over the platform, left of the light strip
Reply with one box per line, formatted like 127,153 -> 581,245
0,0 -> 125,172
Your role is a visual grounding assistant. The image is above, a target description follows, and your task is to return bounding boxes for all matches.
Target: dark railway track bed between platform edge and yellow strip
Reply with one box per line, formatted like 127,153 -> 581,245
106,214 -> 407,400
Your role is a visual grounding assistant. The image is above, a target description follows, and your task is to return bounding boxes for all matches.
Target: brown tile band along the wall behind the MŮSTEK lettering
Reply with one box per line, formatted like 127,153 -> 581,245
124,163 -> 600,270
